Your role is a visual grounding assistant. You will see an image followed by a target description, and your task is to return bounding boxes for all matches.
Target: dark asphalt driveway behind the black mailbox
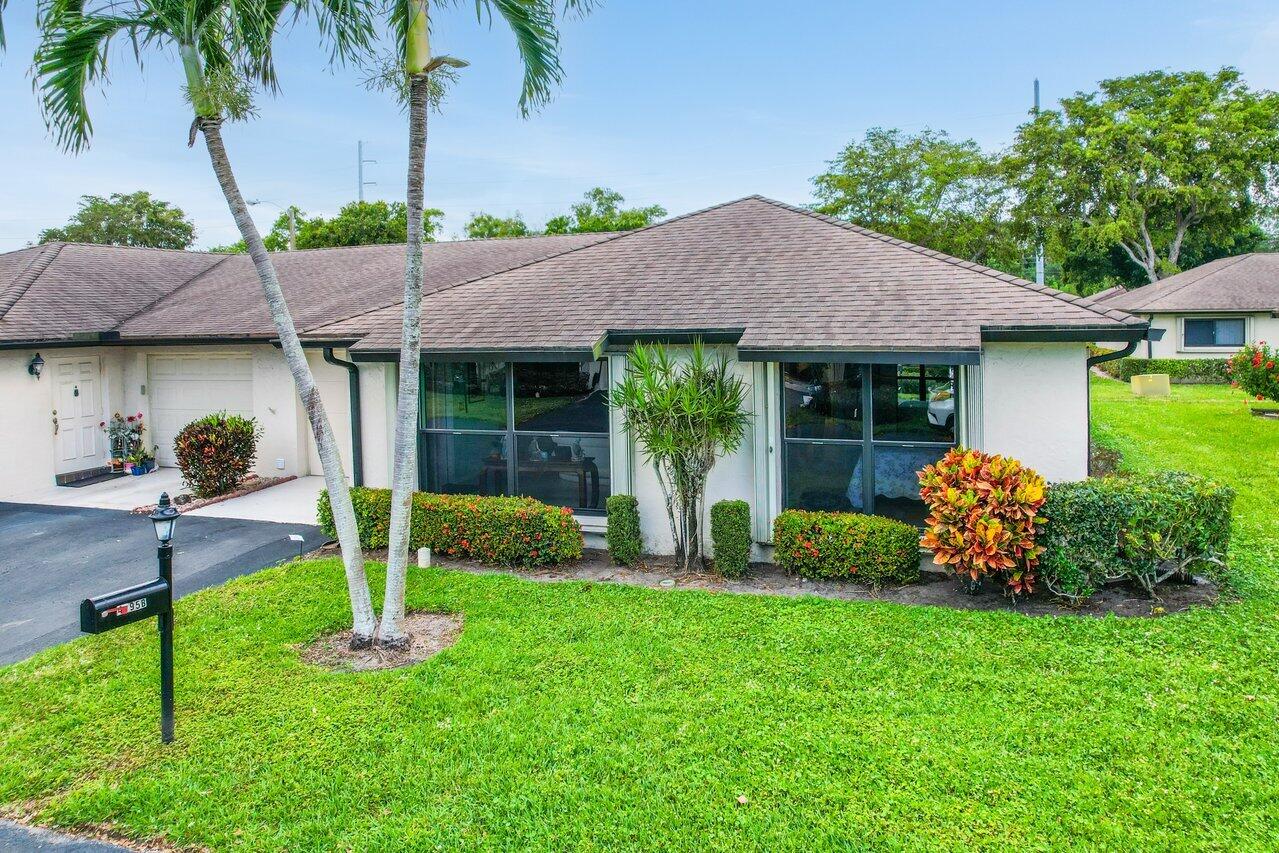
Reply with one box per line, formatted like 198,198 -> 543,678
0,503 -> 325,665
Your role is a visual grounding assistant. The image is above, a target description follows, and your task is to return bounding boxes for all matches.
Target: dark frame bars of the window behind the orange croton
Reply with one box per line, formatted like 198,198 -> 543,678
778,362 -> 963,515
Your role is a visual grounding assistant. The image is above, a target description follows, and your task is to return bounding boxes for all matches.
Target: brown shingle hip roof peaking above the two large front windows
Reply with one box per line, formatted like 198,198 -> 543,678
340,196 -> 1145,350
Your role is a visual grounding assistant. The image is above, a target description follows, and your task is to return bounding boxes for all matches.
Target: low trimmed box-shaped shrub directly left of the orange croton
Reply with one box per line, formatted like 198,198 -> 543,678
773,509 -> 920,587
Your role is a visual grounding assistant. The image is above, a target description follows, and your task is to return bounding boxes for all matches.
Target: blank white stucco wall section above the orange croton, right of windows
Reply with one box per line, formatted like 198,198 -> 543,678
981,344 -> 1088,482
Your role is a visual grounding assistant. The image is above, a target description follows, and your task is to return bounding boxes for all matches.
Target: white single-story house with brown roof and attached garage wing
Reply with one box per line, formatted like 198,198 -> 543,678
0,197 -> 1147,550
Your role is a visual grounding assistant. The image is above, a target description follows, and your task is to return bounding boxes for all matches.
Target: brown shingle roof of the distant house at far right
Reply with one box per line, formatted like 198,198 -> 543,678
1101,252 -> 1279,312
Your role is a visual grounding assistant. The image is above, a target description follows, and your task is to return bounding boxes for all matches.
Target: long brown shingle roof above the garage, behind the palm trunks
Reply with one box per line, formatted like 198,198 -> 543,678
0,234 -> 613,340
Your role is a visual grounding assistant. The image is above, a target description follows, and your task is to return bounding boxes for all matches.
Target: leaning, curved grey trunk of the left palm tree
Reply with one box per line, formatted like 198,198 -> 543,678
197,119 -> 377,647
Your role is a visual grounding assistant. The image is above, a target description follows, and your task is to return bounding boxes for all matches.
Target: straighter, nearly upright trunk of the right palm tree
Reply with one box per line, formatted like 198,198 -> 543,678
377,73 -> 428,647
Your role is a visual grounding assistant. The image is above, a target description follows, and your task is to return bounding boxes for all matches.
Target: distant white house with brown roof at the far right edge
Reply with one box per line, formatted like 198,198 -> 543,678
1092,253 -> 1279,358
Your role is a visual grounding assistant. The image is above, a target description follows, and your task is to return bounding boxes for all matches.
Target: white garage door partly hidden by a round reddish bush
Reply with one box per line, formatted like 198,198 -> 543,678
147,354 -> 253,466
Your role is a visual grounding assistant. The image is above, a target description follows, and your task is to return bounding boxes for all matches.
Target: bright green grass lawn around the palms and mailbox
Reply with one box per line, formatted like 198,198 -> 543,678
0,380 -> 1279,850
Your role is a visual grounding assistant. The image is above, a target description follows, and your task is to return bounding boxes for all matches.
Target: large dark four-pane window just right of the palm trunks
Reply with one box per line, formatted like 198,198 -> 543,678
418,361 -> 609,513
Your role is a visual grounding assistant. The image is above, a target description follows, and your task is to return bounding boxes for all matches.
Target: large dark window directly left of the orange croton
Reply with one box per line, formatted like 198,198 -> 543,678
781,363 -> 958,524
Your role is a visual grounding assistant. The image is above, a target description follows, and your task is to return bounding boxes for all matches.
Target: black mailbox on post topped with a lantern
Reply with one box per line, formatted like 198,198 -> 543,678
81,492 -> 178,743
